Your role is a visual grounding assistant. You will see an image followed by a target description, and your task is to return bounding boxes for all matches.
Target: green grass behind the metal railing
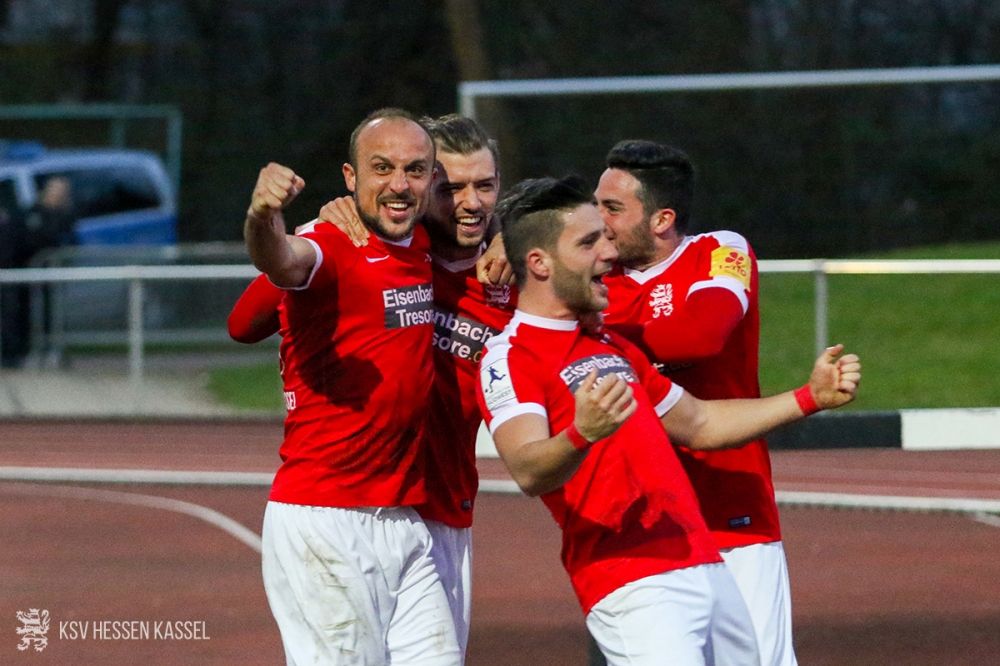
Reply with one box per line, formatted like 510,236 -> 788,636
209,243 -> 1000,411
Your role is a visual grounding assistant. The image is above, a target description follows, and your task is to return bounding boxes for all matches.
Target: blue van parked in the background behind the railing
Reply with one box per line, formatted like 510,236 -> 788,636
0,141 -> 177,366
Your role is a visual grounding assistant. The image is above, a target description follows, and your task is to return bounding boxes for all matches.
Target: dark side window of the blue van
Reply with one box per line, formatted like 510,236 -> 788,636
35,167 -> 160,217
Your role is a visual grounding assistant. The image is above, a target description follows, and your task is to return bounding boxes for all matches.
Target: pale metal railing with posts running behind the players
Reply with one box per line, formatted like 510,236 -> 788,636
0,259 -> 1000,384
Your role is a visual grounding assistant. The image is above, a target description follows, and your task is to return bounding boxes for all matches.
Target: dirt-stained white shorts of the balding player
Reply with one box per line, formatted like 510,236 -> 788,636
261,502 -> 461,666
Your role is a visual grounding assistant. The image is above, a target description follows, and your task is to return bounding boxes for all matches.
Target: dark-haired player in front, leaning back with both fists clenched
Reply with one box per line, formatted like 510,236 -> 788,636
479,179 -> 861,666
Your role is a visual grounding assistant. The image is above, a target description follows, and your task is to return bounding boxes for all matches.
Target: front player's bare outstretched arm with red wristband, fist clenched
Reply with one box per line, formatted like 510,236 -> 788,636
661,345 -> 861,450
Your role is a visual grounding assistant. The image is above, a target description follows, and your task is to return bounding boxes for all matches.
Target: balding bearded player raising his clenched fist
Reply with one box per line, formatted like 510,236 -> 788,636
244,109 -> 461,665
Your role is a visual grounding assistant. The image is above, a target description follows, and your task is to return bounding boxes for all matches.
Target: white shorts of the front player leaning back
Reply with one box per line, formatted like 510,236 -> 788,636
587,562 -> 760,666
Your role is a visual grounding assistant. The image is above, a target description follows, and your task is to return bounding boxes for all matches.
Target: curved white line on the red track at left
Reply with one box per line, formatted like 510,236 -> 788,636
0,483 -> 261,553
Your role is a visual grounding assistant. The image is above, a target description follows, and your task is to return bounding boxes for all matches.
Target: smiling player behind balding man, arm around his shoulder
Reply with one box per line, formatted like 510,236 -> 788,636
229,115 -> 517,654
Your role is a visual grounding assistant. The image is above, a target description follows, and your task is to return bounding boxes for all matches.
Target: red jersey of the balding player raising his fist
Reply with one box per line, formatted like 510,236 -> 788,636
270,227 -> 434,507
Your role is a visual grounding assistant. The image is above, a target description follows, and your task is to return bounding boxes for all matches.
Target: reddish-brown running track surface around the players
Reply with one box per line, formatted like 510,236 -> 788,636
0,421 -> 1000,666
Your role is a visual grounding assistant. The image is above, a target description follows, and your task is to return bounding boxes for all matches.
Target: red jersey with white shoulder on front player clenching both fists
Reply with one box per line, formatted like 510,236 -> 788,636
477,311 -> 722,613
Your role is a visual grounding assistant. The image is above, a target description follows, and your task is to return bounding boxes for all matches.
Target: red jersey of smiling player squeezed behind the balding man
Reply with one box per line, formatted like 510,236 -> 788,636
416,252 -> 517,528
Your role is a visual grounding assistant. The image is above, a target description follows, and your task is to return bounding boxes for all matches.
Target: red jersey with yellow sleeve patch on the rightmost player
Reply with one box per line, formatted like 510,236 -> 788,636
604,231 -> 781,548
